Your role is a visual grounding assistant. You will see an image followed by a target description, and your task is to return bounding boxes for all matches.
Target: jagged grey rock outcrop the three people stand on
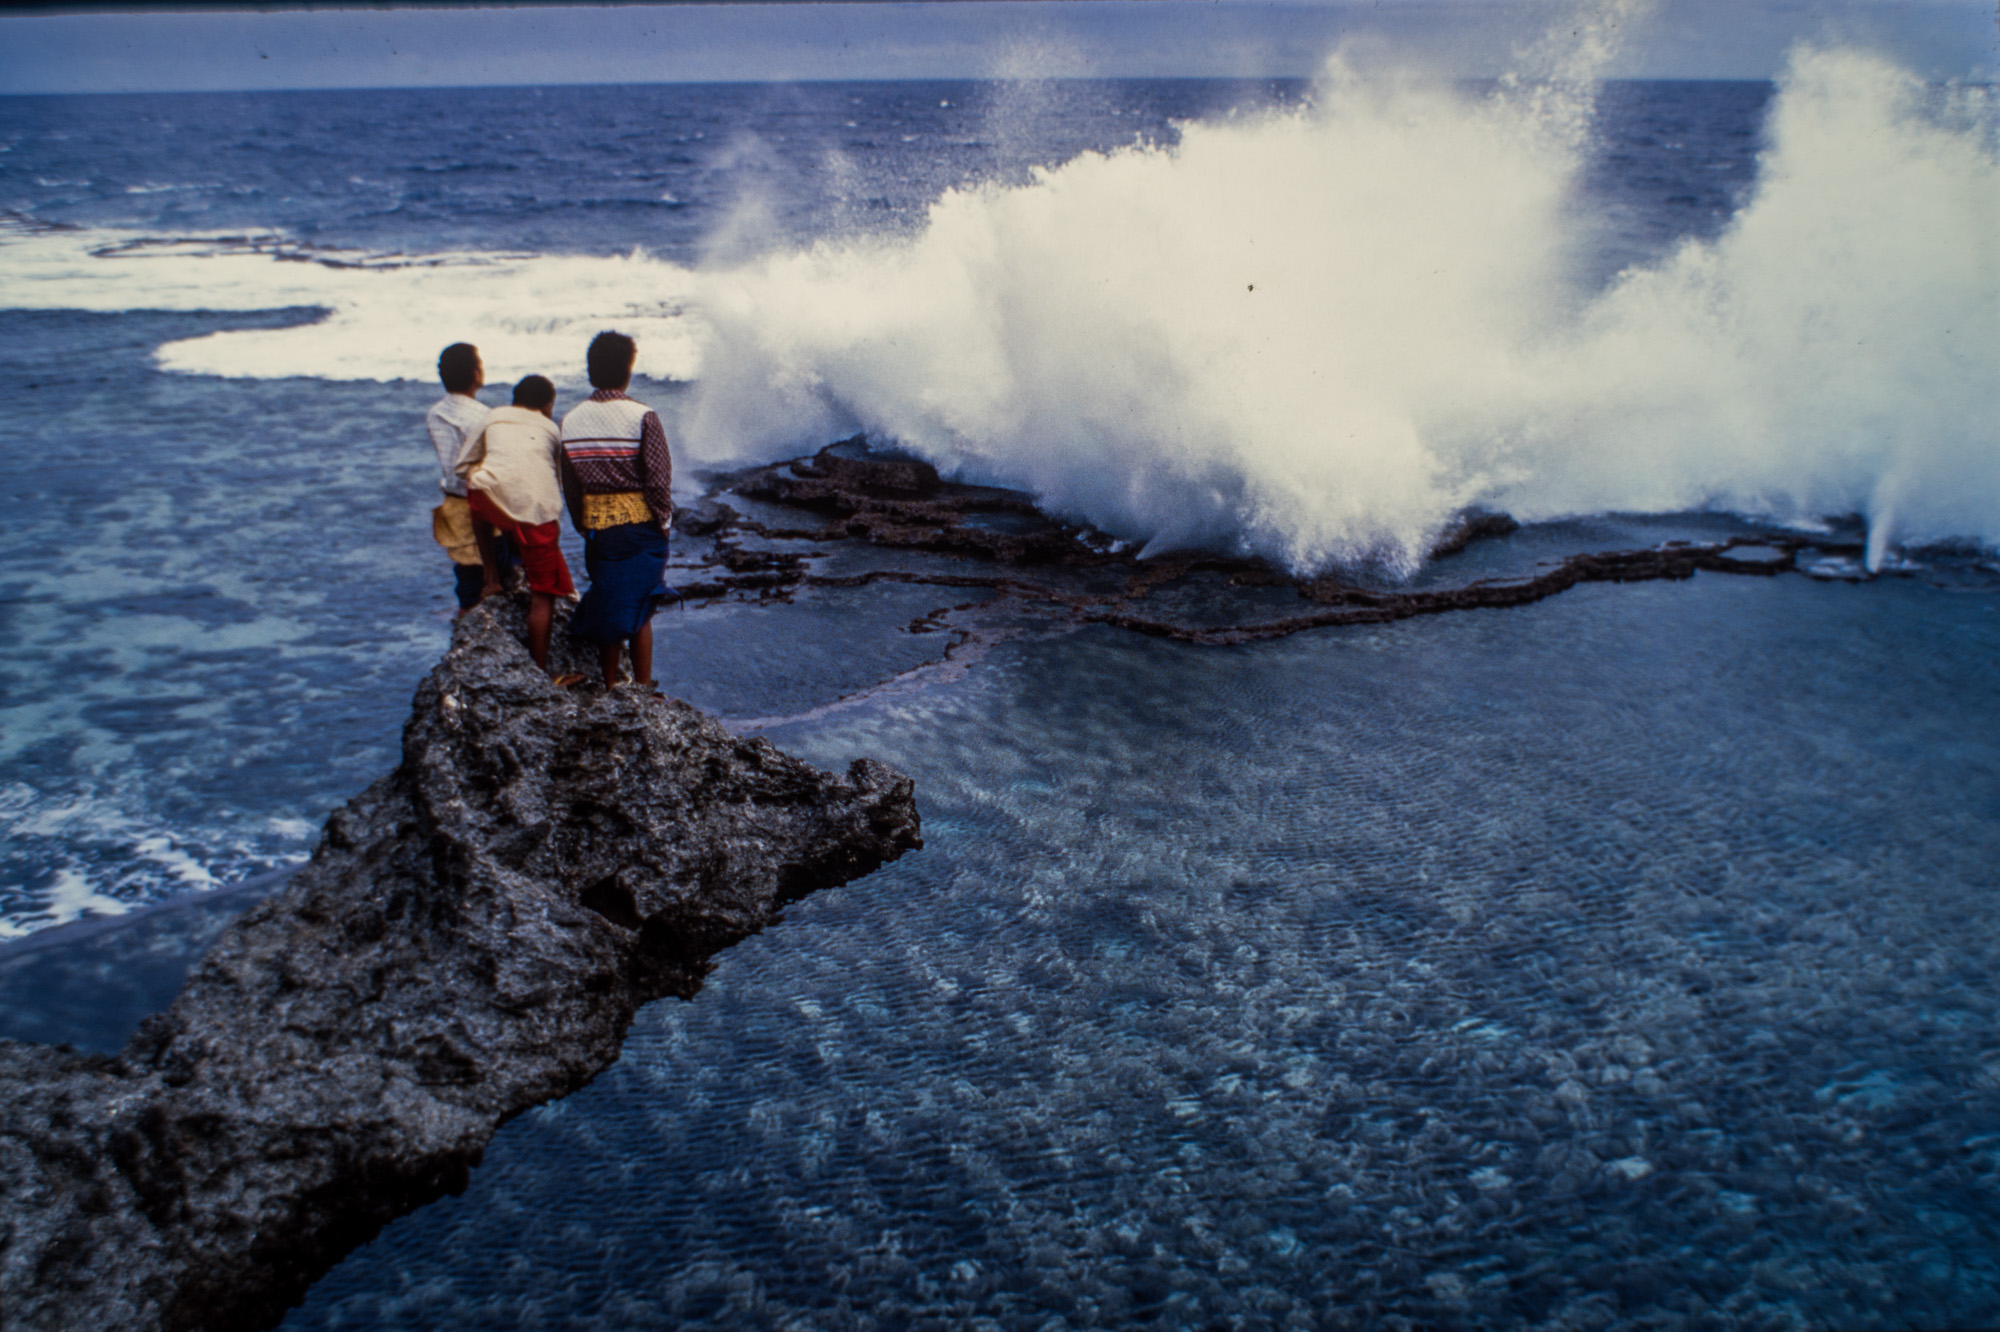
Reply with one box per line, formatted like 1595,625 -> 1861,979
0,602 -> 922,1332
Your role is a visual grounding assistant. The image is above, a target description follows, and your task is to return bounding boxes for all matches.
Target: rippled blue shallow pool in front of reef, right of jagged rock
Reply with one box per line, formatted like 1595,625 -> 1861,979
288,576 -> 2000,1328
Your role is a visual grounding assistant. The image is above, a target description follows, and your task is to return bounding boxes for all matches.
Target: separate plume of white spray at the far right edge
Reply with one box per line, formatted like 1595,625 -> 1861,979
1496,54 -> 2000,568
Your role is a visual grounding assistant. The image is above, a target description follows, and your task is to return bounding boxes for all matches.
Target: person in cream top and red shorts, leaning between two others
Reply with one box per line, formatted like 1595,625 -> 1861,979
458,374 -> 576,670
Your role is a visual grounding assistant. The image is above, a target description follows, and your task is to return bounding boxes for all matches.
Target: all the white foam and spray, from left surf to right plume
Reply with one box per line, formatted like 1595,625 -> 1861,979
0,40 -> 2000,568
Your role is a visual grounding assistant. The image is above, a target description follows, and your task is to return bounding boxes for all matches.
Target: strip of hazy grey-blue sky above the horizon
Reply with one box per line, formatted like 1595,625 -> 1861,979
0,0 -> 2000,92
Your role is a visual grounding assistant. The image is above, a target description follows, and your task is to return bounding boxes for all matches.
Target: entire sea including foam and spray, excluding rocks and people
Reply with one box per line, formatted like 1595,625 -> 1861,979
0,52 -> 2000,1328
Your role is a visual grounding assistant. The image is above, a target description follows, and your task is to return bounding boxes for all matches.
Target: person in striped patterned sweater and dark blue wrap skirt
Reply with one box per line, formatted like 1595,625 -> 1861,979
562,332 -> 674,692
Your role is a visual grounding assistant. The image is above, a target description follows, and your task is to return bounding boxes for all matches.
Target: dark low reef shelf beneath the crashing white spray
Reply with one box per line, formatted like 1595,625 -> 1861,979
678,436 -> 1864,644
